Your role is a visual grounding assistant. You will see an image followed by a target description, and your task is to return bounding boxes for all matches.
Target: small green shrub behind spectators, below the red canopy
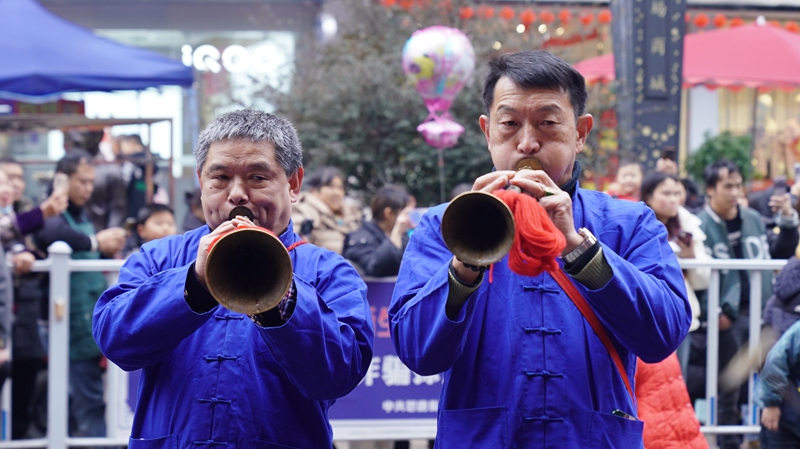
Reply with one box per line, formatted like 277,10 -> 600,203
686,131 -> 753,182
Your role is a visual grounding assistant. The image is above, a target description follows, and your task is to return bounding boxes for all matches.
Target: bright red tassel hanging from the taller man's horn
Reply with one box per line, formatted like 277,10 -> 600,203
493,190 -> 567,277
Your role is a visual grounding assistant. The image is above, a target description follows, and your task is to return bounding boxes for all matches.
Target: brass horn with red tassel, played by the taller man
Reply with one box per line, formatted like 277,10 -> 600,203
442,159 -> 542,267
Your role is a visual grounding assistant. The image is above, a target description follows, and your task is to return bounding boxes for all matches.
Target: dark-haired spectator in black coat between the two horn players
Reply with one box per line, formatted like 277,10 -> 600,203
342,186 -> 415,277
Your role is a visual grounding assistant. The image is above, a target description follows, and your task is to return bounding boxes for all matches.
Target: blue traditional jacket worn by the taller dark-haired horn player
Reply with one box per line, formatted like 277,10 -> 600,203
389,189 -> 692,449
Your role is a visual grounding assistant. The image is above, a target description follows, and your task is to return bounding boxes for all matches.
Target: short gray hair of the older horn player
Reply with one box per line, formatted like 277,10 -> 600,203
194,109 -> 303,176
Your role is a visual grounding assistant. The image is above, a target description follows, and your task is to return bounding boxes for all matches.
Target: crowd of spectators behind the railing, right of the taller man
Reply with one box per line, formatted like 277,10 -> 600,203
607,154 -> 800,449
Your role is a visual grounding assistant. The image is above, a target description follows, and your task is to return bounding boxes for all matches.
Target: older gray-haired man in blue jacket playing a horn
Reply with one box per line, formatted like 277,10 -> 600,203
94,111 -> 373,449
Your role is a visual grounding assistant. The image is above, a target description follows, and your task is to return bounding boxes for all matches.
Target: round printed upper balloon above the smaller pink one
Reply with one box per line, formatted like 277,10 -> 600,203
403,25 -> 475,113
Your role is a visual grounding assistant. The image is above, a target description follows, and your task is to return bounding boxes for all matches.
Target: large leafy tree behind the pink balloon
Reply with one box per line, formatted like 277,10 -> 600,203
263,0 -> 608,206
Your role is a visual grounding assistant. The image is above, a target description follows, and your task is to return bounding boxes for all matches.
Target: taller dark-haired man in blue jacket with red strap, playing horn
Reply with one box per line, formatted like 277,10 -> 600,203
389,51 -> 691,448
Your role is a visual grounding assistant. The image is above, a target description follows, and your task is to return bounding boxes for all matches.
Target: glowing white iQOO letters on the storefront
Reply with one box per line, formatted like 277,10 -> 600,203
181,44 -> 274,73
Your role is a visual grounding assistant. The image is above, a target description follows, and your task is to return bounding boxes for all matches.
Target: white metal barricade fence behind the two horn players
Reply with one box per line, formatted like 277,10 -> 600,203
0,242 -> 786,449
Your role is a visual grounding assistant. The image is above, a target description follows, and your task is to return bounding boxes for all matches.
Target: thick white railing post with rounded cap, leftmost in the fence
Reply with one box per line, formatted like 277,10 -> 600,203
47,242 -> 72,449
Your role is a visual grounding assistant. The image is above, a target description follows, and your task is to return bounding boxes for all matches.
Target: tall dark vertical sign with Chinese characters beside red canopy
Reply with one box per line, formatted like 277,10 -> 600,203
611,0 -> 686,169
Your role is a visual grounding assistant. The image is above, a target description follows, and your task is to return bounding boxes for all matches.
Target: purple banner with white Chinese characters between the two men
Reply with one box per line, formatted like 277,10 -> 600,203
330,281 -> 442,419
